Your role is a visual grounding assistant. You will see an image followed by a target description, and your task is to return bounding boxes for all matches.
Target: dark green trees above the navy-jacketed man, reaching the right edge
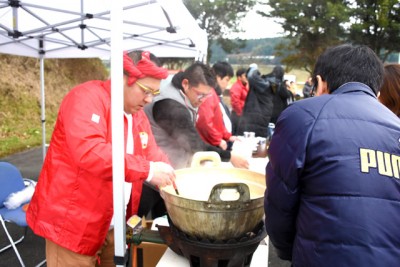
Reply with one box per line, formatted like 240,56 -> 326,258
259,0 -> 400,73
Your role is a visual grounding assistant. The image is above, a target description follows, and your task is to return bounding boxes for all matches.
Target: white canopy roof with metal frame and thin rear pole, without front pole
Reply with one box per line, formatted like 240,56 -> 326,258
0,0 -> 208,158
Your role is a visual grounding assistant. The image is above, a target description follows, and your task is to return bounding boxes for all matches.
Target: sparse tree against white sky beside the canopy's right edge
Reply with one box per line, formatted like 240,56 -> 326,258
183,0 -> 257,60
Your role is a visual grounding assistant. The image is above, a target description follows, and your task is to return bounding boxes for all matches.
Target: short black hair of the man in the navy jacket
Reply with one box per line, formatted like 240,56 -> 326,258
313,44 -> 384,95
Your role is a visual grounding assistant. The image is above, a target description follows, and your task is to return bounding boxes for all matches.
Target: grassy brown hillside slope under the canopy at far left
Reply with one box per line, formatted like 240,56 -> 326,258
0,54 -> 108,157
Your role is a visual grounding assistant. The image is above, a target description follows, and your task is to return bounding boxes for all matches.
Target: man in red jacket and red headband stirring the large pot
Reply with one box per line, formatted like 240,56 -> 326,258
26,51 -> 175,266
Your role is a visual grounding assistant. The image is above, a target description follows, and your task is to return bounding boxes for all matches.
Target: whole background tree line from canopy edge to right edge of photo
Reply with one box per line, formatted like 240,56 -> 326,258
184,0 -> 400,72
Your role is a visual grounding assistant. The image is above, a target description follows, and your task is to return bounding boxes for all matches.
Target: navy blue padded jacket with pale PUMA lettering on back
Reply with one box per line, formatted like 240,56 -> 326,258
264,83 -> 400,267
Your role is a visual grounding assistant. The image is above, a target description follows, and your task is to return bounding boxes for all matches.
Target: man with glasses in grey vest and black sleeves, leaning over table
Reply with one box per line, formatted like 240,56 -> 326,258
139,62 -> 249,218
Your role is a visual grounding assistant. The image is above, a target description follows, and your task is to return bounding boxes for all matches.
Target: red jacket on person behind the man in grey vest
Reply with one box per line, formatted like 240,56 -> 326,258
196,90 -> 232,146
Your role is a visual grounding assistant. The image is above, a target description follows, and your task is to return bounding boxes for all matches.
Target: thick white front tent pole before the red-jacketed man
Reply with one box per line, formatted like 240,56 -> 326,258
111,0 -> 127,267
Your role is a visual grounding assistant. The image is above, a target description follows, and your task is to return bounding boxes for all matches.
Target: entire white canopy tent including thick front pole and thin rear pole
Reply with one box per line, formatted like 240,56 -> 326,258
0,0 -> 208,266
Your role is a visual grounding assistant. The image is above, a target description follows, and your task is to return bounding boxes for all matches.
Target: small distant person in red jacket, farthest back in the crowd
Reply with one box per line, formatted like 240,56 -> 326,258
229,68 -> 249,135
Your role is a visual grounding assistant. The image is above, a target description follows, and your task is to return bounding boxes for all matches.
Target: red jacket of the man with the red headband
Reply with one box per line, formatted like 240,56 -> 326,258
26,80 -> 168,256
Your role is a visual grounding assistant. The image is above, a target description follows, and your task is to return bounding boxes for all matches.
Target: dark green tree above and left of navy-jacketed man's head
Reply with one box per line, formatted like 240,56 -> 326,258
261,0 -> 349,73
